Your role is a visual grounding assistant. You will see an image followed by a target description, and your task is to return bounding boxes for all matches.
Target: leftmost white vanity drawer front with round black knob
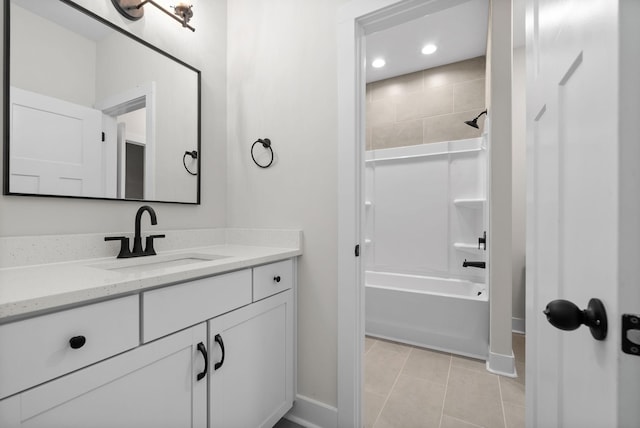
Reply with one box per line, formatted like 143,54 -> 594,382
0,296 -> 140,399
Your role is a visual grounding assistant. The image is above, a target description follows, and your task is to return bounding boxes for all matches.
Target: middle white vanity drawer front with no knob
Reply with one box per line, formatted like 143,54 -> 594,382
142,269 -> 251,342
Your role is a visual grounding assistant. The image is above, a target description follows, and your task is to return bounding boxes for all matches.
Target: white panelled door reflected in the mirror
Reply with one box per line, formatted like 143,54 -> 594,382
9,87 -> 104,197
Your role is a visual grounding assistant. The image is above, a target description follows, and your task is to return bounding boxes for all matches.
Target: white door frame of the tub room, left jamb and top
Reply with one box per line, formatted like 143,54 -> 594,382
337,0 -> 482,428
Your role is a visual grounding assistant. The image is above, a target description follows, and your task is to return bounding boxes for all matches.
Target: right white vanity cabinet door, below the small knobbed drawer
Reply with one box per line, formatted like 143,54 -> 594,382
209,290 -> 293,428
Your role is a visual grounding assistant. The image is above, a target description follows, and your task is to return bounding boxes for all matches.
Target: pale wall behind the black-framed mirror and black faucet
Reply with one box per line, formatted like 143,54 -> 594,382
0,0 -> 227,236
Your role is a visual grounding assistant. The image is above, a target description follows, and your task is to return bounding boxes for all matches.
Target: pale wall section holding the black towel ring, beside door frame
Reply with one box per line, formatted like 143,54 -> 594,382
227,0 -> 346,406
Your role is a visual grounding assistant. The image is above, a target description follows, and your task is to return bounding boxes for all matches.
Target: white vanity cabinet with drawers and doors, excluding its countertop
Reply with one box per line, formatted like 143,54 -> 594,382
0,260 -> 295,428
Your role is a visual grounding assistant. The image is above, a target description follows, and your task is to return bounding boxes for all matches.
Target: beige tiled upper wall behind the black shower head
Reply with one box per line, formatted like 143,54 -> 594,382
366,56 -> 485,150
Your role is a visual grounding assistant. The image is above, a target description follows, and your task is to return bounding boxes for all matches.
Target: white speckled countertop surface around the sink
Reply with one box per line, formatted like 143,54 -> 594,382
0,244 -> 302,323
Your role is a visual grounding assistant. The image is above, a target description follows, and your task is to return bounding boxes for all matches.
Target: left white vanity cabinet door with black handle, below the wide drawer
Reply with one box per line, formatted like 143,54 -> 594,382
0,324 -> 207,428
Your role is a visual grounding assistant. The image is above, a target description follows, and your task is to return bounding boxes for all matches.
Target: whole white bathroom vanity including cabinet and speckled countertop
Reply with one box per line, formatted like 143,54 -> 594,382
0,234 -> 301,428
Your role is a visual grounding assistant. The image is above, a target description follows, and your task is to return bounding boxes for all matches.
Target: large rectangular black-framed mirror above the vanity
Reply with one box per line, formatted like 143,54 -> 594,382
4,0 -> 201,204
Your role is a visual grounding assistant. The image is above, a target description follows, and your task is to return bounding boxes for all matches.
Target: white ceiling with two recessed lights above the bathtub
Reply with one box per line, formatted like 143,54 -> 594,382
366,0 -> 489,82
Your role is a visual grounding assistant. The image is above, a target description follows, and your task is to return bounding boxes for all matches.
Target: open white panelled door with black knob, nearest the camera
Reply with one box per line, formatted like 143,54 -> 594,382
526,0 -> 640,428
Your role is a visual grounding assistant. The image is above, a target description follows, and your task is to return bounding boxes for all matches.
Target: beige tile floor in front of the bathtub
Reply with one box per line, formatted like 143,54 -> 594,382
364,334 -> 525,428
